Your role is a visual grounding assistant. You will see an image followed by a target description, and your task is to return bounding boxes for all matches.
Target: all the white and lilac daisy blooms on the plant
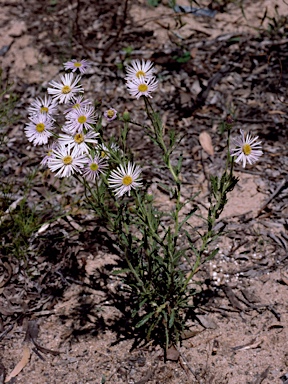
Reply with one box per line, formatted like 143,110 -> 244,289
25,60 -> 262,201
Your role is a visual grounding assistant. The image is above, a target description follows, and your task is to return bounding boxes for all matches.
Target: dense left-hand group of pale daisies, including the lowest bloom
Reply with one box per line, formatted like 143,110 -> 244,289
24,60 -> 142,197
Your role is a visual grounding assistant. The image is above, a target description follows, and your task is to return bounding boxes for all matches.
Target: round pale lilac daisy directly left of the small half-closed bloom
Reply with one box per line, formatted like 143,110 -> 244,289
63,105 -> 96,135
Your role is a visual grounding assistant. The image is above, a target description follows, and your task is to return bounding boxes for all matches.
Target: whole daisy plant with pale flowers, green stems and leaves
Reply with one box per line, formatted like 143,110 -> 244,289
25,60 -> 262,351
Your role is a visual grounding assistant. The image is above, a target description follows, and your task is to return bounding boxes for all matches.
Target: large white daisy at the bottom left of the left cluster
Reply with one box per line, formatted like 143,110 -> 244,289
47,145 -> 87,177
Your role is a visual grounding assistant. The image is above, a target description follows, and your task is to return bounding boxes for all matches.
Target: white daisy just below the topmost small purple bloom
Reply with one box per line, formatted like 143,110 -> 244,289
47,73 -> 84,103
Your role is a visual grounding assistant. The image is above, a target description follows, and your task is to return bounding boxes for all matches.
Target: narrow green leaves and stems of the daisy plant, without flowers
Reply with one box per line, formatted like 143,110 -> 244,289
79,97 -> 237,350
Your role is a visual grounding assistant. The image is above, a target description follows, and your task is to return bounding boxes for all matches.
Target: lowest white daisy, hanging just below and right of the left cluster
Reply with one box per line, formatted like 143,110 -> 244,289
108,162 -> 142,197
